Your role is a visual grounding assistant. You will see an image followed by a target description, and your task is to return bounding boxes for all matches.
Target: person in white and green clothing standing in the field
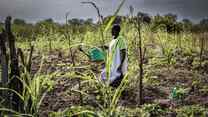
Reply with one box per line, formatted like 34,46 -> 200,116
101,24 -> 128,87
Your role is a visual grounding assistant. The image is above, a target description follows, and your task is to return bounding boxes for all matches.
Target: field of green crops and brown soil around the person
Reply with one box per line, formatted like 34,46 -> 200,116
0,0 -> 208,117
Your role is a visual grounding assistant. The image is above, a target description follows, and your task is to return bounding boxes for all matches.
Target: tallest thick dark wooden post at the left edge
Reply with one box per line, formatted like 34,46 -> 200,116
5,16 -> 23,112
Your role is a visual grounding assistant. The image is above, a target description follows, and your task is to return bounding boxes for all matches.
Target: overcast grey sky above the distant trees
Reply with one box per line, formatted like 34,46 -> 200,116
0,0 -> 208,22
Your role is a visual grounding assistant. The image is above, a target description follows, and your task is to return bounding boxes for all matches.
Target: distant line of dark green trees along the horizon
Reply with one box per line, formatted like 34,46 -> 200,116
0,12 -> 208,38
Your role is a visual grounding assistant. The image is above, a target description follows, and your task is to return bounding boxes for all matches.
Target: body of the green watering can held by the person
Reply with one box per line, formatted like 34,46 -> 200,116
88,47 -> 106,61
